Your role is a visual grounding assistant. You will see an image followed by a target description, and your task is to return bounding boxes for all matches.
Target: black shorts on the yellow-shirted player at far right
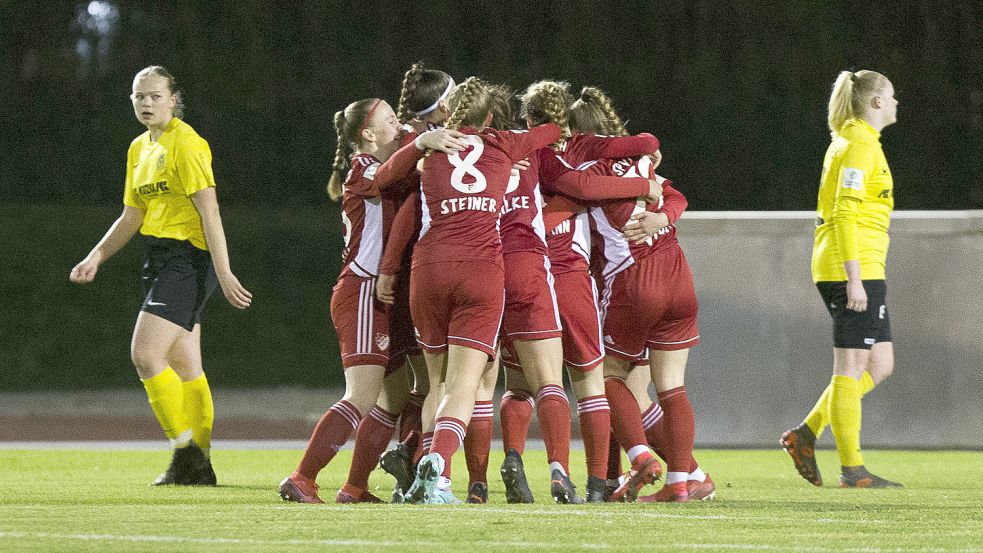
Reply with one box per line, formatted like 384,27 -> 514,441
816,280 -> 891,349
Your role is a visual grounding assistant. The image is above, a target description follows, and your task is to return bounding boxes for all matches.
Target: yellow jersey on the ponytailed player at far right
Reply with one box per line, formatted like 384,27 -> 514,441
812,119 -> 894,282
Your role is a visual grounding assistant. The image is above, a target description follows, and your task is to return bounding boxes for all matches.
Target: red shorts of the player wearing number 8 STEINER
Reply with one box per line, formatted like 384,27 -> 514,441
410,261 -> 505,359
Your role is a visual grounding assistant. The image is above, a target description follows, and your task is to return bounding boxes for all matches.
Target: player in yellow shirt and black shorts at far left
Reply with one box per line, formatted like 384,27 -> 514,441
69,66 -> 252,485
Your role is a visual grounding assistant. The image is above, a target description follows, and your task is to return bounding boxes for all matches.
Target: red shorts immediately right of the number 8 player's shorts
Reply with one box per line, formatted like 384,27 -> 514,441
502,252 -> 561,340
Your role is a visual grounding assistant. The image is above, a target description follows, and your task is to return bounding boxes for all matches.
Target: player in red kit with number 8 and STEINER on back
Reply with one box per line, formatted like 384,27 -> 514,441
407,77 -> 560,503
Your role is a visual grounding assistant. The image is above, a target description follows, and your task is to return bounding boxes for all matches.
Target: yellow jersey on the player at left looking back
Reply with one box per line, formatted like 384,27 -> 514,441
123,117 -> 215,250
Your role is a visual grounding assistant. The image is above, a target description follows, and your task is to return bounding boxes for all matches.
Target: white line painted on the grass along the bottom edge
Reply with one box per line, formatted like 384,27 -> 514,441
0,531 -> 983,553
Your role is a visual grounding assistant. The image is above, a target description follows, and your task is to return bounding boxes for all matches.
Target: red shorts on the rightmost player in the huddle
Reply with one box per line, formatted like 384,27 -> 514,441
604,245 -> 700,361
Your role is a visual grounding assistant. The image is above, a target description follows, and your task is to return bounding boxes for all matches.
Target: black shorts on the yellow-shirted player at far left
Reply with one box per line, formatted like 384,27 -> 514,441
140,235 -> 218,331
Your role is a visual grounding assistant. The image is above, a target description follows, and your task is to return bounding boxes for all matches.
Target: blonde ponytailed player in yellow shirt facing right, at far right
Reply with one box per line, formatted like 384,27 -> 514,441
781,71 -> 901,488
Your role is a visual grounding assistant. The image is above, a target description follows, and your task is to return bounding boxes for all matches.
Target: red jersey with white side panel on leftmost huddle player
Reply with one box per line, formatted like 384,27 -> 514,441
339,140 -> 422,278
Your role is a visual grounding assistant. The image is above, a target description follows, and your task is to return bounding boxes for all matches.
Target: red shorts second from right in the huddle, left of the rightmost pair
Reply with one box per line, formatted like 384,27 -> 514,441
553,271 -> 604,371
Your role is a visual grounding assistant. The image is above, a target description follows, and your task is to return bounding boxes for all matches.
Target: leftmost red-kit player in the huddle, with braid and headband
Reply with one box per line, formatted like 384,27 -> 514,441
278,98 -> 461,503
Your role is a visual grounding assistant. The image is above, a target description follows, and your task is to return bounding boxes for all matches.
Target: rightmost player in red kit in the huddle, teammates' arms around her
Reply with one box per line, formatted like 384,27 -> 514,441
570,88 -> 712,502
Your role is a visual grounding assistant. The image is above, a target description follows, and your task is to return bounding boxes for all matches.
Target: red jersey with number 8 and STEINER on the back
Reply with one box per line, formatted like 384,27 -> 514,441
413,124 -> 560,267
